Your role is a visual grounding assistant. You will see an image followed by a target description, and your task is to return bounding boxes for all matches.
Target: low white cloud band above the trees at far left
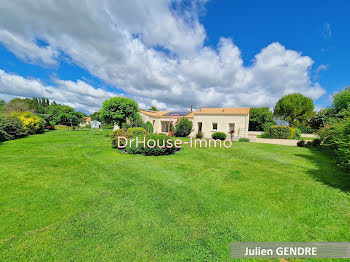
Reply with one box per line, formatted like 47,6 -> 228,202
0,69 -> 118,113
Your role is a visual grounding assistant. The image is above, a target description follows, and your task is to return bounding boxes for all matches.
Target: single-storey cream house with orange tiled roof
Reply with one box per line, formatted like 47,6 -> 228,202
140,108 -> 249,139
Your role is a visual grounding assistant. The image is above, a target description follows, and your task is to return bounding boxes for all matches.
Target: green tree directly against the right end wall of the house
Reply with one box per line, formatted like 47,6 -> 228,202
249,107 -> 276,131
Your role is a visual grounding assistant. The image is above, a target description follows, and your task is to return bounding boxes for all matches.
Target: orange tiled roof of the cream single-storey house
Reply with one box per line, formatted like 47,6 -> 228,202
141,107 -> 250,118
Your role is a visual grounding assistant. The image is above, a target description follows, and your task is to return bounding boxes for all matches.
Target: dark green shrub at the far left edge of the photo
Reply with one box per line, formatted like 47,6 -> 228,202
0,116 -> 26,141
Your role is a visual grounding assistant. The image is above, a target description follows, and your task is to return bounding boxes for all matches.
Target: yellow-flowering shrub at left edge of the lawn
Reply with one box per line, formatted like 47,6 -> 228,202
12,112 -> 45,135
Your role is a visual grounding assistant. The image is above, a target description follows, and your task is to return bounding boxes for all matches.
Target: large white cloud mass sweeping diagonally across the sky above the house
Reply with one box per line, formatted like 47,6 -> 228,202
0,0 -> 325,109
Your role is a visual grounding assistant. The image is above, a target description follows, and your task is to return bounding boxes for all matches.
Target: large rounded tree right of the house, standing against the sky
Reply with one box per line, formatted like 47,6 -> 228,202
274,93 -> 314,127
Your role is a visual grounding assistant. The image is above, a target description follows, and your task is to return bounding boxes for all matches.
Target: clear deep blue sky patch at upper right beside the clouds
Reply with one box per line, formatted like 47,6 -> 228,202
201,0 -> 350,104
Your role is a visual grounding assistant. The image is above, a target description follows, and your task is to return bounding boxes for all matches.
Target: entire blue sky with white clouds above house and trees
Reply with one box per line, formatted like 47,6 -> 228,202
0,0 -> 350,114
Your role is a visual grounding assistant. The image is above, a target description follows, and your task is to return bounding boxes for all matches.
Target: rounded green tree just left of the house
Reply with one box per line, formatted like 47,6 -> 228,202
100,97 -> 138,127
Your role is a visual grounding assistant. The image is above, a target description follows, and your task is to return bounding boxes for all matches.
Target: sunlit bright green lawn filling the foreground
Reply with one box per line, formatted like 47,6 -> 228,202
0,130 -> 350,261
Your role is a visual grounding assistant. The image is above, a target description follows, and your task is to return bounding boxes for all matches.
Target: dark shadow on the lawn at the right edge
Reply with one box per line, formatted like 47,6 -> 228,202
296,148 -> 350,193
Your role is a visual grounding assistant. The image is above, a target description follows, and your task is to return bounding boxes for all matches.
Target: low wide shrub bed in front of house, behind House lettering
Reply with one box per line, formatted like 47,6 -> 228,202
125,134 -> 180,156
